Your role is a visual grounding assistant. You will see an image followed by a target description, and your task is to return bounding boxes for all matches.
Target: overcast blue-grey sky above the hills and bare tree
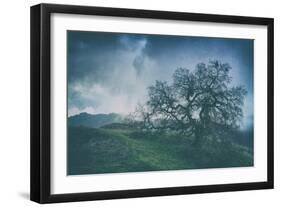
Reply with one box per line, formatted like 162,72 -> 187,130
67,31 -> 254,127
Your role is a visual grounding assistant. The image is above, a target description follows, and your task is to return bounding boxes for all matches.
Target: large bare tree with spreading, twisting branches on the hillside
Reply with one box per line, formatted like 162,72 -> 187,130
137,61 -> 247,145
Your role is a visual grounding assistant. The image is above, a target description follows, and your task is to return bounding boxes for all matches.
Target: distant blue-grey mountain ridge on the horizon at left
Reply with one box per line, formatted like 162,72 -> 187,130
68,112 -> 124,128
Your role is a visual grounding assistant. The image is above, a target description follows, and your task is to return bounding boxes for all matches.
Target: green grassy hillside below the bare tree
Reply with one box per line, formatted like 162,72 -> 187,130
68,125 -> 253,175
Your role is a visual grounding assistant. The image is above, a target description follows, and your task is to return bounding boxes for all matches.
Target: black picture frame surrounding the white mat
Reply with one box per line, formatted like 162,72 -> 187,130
30,4 -> 274,203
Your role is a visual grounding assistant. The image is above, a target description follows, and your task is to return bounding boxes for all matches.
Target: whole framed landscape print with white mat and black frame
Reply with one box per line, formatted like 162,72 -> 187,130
31,4 -> 273,203
